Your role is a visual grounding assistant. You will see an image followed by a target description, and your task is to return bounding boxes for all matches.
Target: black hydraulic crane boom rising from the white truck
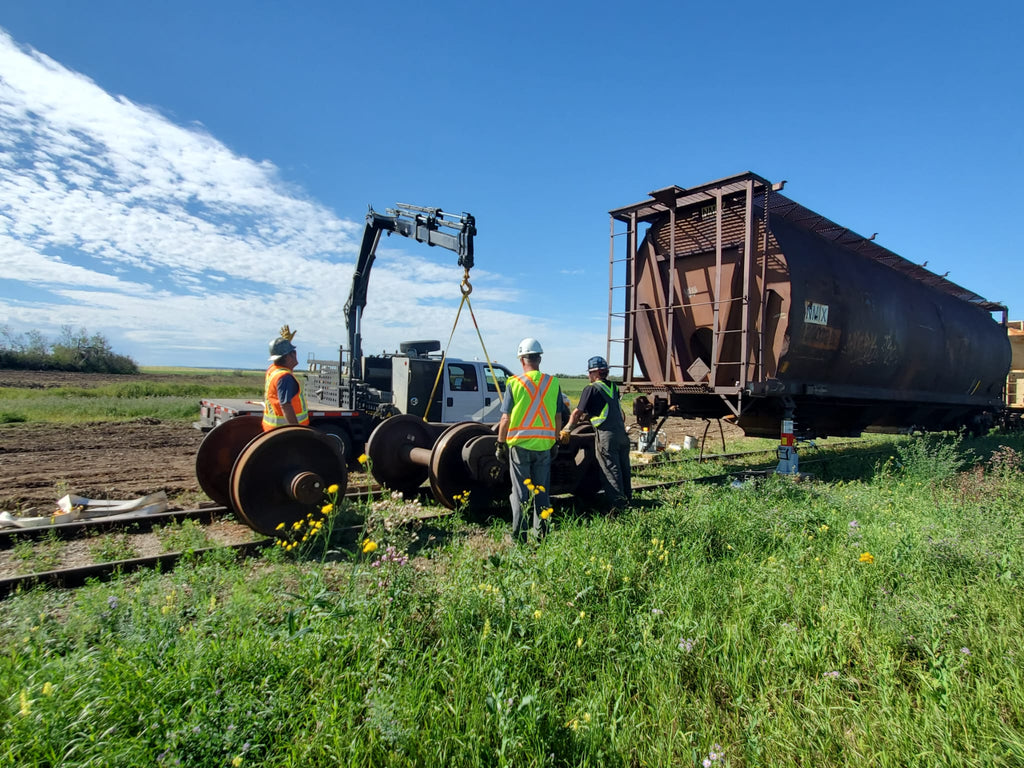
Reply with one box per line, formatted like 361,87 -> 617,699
345,203 -> 476,385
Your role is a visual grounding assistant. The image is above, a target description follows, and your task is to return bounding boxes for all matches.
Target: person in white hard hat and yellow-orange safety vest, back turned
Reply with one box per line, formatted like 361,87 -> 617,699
495,338 -> 562,541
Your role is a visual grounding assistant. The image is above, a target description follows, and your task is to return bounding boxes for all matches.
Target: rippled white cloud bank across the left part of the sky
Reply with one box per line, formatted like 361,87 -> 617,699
0,30 -> 603,370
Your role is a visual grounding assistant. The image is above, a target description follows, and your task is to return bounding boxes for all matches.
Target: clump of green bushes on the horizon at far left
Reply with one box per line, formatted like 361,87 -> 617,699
0,325 -> 139,374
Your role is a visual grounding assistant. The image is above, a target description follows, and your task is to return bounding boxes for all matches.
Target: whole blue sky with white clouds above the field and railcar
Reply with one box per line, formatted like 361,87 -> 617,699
0,0 -> 1024,374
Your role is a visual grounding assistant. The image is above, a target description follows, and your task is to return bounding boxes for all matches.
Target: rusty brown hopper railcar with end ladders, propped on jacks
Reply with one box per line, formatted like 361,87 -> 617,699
608,173 -> 1011,438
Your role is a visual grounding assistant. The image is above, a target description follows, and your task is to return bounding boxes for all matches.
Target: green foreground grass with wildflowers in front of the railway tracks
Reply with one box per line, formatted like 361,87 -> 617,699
0,436 -> 1024,768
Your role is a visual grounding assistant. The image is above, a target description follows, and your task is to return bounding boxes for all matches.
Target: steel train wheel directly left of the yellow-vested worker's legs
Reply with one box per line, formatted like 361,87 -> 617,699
430,422 -> 509,509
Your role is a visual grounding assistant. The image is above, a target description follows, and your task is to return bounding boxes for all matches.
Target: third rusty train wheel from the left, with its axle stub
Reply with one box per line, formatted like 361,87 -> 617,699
367,414 -> 444,496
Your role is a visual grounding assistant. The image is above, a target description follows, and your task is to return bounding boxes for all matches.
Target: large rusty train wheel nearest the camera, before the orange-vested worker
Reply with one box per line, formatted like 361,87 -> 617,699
230,427 -> 348,536
